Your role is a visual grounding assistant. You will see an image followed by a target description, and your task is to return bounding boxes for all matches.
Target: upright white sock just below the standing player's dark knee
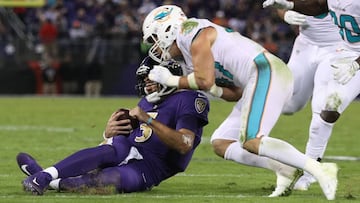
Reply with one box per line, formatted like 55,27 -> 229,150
305,113 -> 334,160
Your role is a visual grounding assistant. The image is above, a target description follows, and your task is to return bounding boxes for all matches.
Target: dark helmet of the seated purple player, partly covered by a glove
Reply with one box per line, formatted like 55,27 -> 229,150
135,56 -> 183,103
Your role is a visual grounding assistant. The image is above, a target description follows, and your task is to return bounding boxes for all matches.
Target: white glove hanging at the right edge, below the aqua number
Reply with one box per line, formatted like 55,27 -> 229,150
331,58 -> 360,85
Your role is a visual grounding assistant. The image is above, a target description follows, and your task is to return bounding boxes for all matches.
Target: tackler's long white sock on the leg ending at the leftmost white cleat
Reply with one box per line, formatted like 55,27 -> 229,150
224,142 -> 296,177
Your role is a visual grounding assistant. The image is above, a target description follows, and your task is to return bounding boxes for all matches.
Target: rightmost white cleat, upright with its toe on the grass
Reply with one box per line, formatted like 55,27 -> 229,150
317,163 -> 339,200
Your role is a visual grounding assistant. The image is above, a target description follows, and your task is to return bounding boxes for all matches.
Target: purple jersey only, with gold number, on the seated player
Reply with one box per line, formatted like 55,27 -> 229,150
128,90 -> 209,176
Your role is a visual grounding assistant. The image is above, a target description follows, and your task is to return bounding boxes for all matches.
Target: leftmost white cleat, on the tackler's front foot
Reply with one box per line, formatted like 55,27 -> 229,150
268,169 -> 303,197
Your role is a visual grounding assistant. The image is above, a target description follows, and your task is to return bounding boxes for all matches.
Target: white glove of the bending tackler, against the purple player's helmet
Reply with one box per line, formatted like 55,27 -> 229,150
149,65 -> 180,87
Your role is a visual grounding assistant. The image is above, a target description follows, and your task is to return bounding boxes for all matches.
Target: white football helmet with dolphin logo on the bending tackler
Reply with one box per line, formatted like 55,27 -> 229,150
142,5 -> 187,63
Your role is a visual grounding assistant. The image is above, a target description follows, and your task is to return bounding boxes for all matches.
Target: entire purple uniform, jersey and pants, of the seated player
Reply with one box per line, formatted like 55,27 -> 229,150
54,90 -> 209,192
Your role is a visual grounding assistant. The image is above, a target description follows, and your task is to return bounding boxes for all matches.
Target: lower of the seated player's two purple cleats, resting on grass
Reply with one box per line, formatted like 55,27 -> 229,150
22,172 -> 52,195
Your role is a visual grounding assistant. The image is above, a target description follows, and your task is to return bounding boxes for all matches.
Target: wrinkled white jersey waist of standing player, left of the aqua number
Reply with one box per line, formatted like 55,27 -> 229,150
299,13 -> 341,47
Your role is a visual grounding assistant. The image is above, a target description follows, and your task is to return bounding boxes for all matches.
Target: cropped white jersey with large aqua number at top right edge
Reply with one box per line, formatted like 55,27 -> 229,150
328,0 -> 360,53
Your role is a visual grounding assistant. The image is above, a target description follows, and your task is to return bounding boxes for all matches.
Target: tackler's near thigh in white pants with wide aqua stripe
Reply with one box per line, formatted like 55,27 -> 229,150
239,53 -> 293,142
